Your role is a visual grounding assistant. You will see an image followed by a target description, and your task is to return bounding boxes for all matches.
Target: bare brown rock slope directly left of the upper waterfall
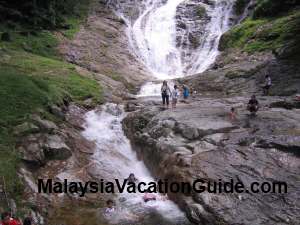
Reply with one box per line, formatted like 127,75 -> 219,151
59,1 -> 147,91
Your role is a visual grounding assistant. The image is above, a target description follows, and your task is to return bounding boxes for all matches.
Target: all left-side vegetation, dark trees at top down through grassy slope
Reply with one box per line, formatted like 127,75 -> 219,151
0,1 -> 102,210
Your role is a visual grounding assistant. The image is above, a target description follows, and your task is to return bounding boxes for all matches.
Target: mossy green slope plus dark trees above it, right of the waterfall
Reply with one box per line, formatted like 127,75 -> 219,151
220,0 -> 300,56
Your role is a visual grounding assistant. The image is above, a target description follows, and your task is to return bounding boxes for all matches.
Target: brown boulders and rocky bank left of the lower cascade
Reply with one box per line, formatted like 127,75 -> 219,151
14,104 -> 105,225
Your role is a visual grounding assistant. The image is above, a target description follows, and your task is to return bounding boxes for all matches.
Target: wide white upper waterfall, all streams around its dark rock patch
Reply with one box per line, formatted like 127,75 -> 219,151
112,0 -> 235,96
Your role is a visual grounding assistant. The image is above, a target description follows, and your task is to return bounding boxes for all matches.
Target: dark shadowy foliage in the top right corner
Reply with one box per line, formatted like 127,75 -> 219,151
253,0 -> 300,18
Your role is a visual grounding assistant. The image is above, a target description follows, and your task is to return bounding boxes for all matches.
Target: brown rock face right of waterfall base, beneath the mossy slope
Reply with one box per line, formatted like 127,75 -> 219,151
179,50 -> 300,96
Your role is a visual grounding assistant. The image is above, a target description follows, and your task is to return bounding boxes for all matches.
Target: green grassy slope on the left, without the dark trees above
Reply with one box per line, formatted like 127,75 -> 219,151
0,42 -> 102,204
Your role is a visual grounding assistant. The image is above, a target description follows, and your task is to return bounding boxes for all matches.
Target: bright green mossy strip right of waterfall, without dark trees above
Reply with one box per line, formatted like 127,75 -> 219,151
220,11 -> 300,53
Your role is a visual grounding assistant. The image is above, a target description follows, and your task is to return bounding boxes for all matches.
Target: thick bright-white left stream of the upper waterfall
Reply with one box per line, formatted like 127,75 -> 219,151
131,0 -> 185,79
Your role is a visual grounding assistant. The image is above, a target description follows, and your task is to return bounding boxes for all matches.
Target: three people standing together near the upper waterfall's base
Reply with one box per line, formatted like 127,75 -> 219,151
161,80 -> 189,108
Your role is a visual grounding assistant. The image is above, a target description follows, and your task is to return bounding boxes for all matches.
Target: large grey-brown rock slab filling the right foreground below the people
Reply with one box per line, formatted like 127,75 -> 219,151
123,97 -> 300,225
